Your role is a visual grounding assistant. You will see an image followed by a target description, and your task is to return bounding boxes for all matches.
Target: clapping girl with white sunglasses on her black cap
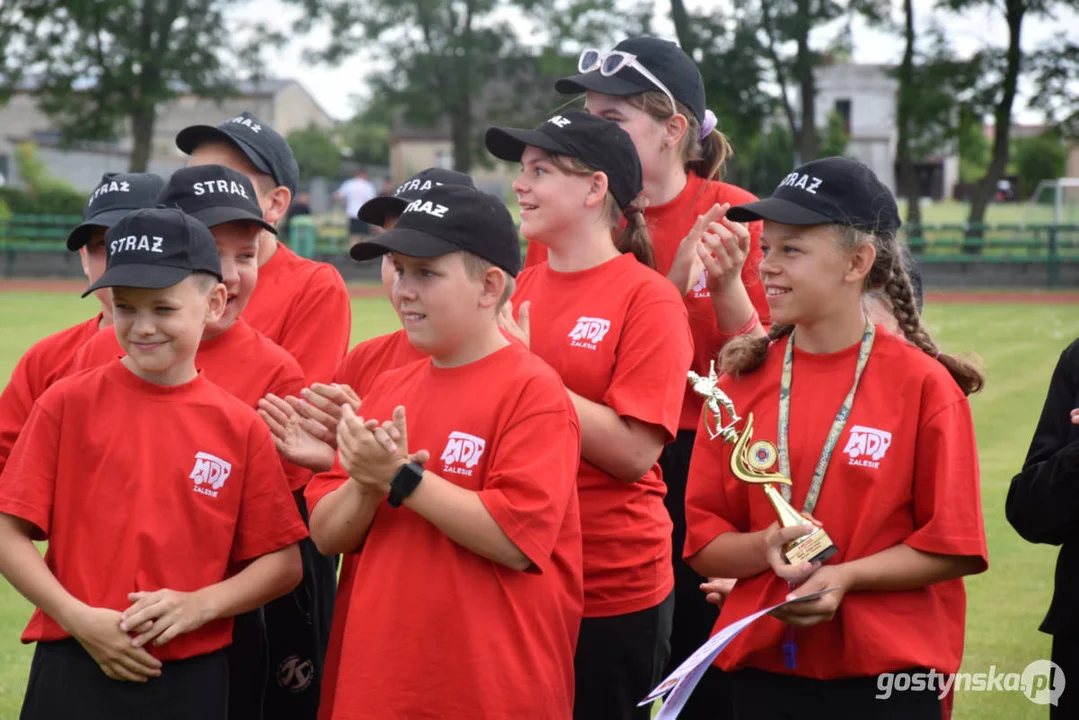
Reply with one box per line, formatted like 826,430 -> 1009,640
543,37 -> 769,708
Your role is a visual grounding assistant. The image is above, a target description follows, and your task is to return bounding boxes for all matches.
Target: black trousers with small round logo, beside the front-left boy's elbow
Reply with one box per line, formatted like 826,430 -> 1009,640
229,493 -> 337,720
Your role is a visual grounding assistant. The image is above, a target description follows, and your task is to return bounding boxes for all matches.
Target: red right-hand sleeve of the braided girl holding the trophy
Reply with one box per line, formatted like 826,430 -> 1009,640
905,385 -> 988,570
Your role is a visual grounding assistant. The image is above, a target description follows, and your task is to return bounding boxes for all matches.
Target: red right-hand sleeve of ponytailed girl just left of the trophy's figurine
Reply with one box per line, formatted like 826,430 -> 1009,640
603,293 -> 693,441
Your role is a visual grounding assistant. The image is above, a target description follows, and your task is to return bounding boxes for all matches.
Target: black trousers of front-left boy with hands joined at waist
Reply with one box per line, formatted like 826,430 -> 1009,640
19,639 -> 229,720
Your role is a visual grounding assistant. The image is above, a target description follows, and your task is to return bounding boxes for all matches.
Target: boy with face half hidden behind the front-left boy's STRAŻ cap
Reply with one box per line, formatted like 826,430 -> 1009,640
70,165 -> 334,720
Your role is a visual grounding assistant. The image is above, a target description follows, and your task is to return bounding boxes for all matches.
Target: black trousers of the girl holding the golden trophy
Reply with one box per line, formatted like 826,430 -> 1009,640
727,668 -> 941,720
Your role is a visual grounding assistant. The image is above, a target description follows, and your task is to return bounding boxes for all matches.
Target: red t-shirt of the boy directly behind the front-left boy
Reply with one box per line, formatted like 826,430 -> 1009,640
72,318 -> 311,490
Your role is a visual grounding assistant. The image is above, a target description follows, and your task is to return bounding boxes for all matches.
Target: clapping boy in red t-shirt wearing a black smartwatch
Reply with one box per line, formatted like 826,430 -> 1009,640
306,186 -> 583,720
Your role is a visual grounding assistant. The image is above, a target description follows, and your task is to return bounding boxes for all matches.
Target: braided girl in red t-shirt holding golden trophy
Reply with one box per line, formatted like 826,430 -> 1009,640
684,158 -> 987,720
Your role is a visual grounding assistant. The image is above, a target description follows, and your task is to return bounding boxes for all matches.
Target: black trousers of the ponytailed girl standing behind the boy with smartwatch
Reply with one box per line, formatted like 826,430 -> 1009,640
573,594 -> 674,720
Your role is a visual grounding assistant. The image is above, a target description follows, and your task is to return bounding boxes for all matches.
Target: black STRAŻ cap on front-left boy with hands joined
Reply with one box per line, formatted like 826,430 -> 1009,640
82,207 -> 221,297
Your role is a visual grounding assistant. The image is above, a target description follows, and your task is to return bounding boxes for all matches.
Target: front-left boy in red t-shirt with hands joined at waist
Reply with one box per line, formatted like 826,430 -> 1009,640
0,209 -> 306,720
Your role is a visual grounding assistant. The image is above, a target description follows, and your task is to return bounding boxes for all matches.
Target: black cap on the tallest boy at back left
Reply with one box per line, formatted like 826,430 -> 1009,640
176,111 -> 300,198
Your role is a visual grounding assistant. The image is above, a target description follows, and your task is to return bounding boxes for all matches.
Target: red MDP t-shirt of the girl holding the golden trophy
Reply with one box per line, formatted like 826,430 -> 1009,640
685,328 -> 987,679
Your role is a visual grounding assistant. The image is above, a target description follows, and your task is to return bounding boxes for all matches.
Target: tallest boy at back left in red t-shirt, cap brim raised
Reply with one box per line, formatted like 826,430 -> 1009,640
176,112 -> 352,386
